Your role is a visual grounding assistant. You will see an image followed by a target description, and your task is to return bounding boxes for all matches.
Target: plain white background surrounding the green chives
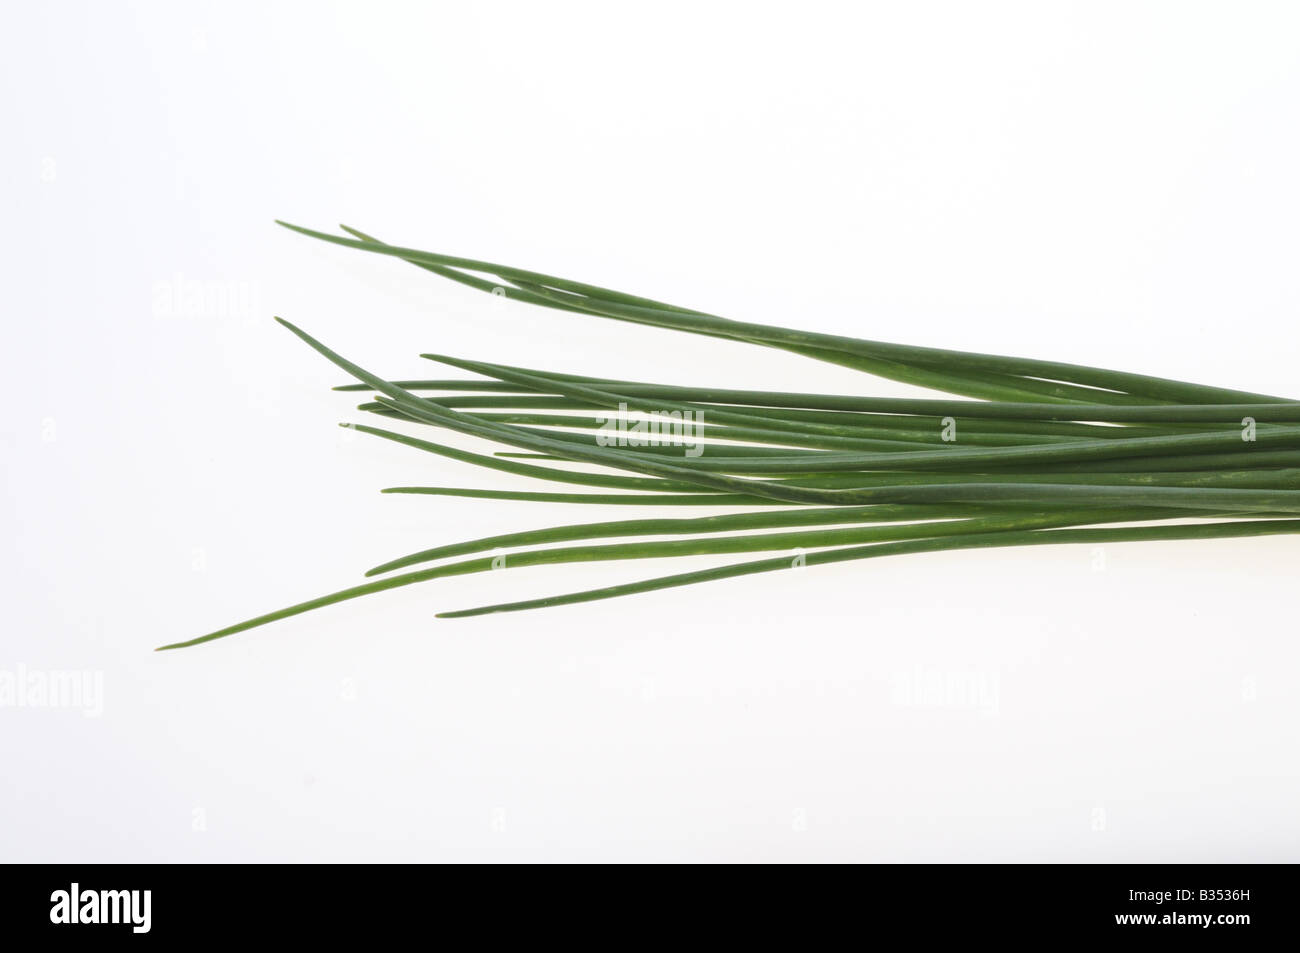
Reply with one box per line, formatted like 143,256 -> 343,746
0,3 -> 1300,861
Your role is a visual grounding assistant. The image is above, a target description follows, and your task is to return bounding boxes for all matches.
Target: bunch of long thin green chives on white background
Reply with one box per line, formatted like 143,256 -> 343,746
161,222 -> 1300,649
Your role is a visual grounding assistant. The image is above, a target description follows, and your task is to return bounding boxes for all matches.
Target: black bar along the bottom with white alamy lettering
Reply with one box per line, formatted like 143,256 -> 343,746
0,865 -> 1279,949
